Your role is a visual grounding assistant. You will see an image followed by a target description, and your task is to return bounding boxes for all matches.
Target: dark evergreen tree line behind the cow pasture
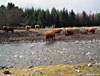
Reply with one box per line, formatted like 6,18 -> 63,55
0,3 -> 100,28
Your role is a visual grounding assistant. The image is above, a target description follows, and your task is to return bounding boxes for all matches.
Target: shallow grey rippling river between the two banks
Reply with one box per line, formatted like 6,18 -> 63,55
0,41 -> 100,67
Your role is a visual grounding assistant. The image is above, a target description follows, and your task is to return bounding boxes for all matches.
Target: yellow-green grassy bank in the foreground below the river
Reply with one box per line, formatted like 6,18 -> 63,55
0,63 -> 100,76
